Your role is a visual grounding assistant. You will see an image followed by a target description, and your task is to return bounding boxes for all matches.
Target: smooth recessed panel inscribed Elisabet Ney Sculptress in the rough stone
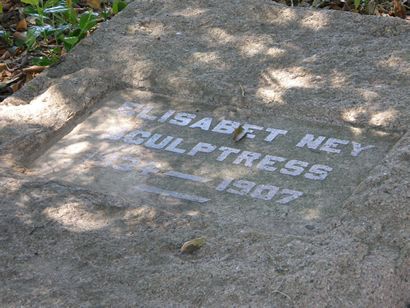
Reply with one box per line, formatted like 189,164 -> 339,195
31,91 -> 399,233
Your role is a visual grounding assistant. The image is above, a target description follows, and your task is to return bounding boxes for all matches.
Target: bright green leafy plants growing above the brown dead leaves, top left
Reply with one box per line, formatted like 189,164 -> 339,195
9,0 -> 127,66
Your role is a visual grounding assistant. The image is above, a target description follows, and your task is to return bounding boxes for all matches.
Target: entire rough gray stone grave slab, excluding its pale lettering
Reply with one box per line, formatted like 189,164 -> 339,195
0,1 -> 410,307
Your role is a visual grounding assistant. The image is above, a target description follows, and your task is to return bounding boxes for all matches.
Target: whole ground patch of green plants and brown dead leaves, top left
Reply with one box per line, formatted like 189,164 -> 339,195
0,0 -> 127,101
